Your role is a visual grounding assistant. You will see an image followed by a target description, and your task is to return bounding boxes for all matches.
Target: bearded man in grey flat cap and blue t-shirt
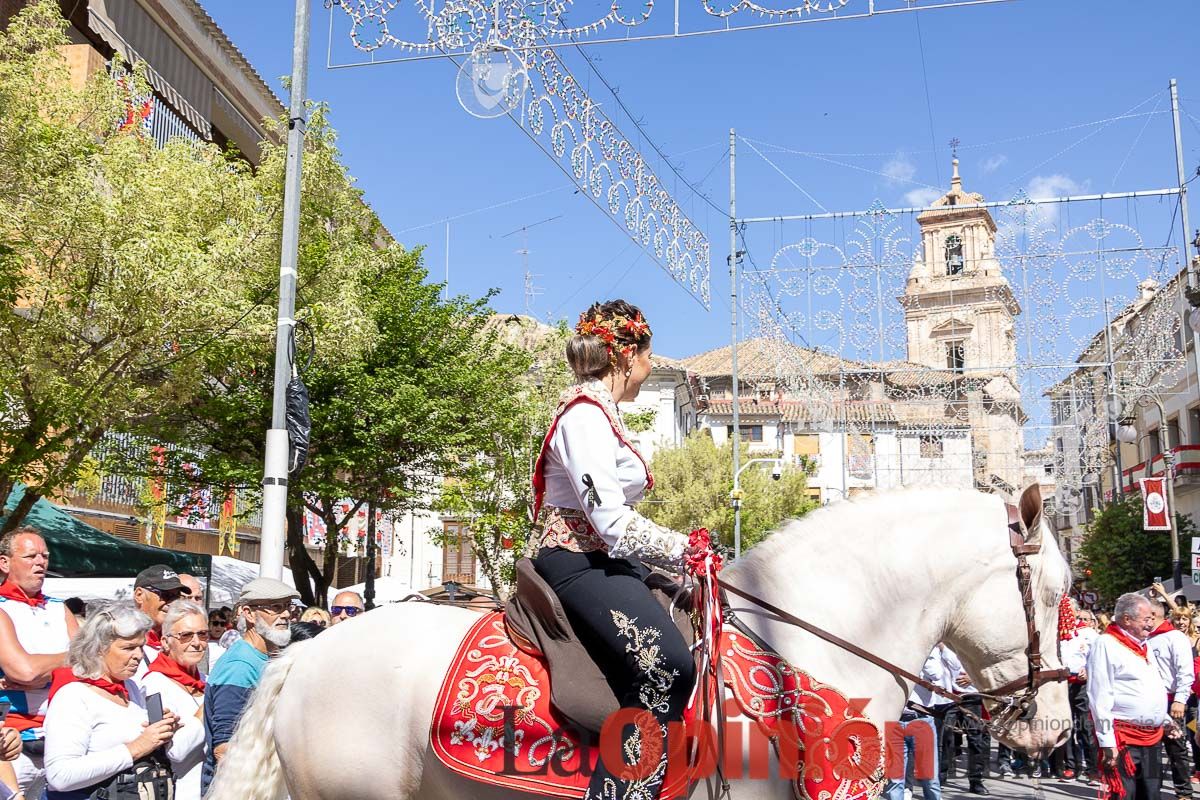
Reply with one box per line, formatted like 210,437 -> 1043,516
200,578 -> 300,794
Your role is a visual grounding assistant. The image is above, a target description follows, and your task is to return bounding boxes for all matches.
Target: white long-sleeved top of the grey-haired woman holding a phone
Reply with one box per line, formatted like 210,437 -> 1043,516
46,680 -> 146,792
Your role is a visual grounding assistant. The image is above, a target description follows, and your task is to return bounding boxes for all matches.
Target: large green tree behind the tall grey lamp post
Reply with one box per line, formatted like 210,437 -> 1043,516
130,104 -> 526,603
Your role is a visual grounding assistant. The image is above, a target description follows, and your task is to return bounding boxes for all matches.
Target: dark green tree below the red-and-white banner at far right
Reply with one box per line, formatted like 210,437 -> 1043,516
1078,497 -> 1196,602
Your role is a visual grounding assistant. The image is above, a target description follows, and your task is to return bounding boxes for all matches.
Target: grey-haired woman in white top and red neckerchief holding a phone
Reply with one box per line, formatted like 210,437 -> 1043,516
46,602 -> 179,800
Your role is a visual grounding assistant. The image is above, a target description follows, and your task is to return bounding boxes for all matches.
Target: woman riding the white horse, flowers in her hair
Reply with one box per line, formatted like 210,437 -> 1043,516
530,300 -> 695,800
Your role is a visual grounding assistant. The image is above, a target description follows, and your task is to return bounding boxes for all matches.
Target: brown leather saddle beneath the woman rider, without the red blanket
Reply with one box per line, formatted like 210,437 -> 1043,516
504,559 -> 695,734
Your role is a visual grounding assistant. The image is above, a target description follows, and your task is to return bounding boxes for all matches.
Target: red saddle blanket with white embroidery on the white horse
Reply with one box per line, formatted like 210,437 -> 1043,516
430,612 -> 883,800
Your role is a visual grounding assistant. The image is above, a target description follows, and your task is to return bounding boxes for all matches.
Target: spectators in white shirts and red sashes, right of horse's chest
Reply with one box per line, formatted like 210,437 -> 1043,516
884,584 -> 1200,800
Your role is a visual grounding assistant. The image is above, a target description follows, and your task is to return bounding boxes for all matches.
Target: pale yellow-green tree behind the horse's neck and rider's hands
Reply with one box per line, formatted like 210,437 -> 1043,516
640,431 -> 816,549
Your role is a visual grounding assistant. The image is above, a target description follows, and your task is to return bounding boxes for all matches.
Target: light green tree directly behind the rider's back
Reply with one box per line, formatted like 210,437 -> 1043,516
433,317 -> 571,596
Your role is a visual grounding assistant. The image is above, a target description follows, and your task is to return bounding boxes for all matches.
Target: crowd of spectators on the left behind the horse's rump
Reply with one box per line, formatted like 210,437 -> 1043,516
0,528 -> 365,800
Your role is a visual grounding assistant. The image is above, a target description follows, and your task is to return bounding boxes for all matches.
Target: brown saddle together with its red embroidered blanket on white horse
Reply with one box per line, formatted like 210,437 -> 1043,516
430,559 -> 883,800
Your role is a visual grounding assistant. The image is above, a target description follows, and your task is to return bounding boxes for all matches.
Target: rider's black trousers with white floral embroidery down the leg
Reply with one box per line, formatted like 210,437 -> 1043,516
534,547 -> 695,800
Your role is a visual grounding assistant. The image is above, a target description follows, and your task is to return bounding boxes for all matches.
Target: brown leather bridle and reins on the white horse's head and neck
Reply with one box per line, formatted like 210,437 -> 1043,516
721,504 -> 1070,721
